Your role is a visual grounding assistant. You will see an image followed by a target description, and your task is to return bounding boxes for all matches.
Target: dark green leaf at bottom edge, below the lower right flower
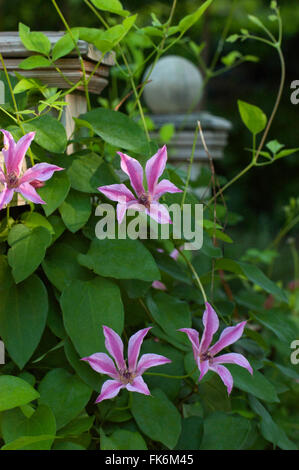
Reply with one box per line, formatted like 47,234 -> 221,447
200,411 -> 251,450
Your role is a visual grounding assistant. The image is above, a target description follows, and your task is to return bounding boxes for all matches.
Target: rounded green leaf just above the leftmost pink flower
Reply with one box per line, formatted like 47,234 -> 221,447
23,114 -> 67,153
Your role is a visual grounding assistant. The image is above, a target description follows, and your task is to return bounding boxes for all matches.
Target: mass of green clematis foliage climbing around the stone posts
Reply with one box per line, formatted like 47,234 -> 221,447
0,0 -> 299,451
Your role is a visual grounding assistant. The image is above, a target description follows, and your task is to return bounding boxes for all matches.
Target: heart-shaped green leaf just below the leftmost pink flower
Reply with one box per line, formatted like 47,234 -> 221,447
7,224 -> 52,284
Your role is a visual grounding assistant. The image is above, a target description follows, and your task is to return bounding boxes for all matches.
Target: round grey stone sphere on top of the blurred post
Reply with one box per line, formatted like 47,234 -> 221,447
143,55 -> 203,114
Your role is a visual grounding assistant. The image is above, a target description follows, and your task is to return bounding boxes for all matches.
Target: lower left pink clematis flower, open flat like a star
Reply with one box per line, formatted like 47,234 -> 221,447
82,325 -> 171,403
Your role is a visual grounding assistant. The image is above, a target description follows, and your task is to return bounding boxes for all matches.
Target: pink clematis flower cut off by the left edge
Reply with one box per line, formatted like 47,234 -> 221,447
0,129 -> 63,209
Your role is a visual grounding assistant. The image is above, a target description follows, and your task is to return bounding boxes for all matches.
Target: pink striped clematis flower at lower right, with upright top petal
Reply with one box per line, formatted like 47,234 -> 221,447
179,302 -> 253,394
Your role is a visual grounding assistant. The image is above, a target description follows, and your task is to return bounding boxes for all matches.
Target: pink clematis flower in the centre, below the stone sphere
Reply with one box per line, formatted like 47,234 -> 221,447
98,145 -> 182,224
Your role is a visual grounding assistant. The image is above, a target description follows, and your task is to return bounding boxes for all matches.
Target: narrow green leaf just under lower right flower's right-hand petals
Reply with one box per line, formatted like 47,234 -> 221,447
225,364 -> 279,403
